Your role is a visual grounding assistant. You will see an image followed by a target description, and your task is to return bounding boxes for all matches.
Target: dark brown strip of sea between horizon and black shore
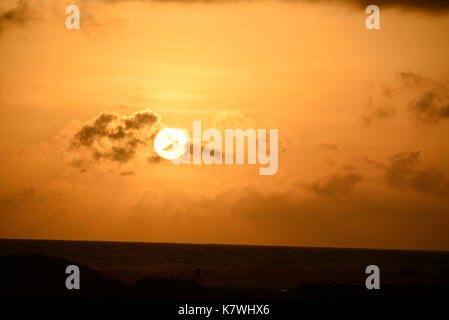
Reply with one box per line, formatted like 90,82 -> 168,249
0,239 -> 449,272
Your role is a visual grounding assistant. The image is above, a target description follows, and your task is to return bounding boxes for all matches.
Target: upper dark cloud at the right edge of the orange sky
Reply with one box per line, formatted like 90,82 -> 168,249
398,72 -> 449,124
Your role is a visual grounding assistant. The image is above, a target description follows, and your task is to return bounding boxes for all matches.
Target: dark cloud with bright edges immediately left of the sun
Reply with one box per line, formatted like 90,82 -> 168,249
71,109 -> 161,169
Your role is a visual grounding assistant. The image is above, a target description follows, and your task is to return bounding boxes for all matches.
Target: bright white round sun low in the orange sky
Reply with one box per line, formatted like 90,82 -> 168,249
154,128 -> 187,160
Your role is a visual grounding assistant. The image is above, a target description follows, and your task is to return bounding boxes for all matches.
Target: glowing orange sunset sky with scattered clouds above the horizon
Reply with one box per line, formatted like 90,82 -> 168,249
0,0 -> 449,250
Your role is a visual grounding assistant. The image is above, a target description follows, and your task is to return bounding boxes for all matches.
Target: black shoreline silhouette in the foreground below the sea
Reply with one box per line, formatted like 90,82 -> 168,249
0,254 -> 449,301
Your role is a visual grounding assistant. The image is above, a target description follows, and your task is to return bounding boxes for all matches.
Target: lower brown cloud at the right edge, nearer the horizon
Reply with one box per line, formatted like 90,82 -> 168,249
385,151 -> 448,194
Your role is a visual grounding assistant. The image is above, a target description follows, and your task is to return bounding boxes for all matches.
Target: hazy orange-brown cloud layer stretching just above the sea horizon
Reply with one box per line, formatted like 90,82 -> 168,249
0,179 -> 449,249
